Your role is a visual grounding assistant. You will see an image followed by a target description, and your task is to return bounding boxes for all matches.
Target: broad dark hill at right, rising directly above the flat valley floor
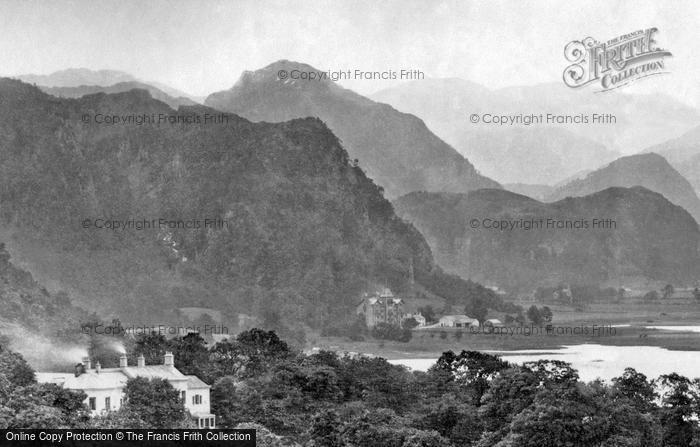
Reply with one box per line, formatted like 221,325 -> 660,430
395,187 -> 700,292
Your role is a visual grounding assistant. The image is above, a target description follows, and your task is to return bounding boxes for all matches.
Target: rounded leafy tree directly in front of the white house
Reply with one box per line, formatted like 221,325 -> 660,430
124,377 -> 187,428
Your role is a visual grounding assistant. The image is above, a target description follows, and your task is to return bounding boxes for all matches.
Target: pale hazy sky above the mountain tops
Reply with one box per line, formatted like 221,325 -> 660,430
0,0 -> 700,106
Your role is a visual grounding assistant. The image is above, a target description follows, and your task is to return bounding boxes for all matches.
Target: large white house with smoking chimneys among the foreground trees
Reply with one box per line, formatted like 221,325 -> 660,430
36,352 -> 216,428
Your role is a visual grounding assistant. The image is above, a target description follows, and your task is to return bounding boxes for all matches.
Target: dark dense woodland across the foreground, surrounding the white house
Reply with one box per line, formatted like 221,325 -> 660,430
0,329 -> 700,447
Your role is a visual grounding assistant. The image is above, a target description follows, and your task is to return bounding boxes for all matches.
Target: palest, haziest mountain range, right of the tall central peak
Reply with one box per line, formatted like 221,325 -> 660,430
371,79 -> 700,185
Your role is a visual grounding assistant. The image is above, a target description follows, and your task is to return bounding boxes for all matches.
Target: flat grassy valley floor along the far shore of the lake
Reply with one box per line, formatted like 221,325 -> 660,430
309,297 -> 700,359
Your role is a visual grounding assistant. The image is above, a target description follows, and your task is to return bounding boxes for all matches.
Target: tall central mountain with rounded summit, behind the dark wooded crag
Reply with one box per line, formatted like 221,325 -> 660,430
205,61 -> 500,197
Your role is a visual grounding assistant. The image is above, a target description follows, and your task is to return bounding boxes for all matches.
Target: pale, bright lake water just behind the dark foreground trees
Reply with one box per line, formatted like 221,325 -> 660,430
389,344 -> 700,382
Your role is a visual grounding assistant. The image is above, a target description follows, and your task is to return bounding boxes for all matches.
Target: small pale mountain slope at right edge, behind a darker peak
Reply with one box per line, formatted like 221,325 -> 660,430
645,126 -> 700,194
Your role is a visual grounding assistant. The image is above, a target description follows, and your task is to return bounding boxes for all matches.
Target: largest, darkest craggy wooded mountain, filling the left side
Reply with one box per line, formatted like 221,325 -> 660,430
0,78 -> 492,328
